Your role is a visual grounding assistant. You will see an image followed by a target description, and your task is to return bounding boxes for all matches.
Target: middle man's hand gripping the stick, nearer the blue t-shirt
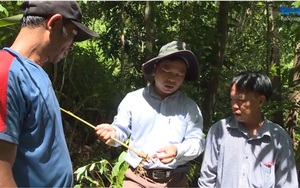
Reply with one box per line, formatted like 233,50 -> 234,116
95,123 -> 116,145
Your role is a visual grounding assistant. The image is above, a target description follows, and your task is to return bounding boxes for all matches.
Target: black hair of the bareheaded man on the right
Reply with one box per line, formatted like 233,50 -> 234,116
230,71 -> 273,100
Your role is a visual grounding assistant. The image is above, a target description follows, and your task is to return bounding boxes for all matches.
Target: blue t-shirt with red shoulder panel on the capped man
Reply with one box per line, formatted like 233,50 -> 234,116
0,48 -> 73,187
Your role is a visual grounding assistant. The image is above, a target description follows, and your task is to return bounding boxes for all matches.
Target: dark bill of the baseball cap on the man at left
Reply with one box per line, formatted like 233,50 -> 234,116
71,20 -> 99,42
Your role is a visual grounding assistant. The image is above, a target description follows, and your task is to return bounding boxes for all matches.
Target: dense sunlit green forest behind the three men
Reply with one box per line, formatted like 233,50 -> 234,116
0,1 -> 300,187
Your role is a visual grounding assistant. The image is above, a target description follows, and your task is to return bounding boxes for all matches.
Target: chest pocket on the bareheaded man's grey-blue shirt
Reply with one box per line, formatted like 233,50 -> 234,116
260,162 -> 275,188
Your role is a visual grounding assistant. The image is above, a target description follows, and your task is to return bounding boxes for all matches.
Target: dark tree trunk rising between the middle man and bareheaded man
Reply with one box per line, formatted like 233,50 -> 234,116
202,1 -> 229,129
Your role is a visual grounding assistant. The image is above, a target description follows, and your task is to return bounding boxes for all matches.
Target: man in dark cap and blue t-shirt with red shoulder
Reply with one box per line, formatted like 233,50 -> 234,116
0,1 -> 98,187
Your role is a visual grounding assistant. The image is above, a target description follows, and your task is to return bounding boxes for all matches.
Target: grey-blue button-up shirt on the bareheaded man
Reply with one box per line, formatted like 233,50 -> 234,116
198,117 -> 298,188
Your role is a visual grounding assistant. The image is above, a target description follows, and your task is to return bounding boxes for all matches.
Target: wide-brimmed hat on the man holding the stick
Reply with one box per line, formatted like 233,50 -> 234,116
142,41 -> 199,81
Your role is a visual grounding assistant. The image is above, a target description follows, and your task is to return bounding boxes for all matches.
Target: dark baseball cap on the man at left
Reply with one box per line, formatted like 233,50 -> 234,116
20,1 -> 99,42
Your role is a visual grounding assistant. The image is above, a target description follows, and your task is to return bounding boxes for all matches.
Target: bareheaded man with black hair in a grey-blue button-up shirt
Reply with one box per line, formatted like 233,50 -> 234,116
198,72 -> 298,188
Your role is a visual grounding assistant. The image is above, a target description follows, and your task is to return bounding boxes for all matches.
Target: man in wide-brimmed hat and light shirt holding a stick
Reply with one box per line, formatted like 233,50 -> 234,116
96,41 -> 205,188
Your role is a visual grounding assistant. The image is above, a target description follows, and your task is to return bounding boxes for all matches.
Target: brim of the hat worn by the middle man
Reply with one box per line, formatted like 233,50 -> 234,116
142,50 -> 199,81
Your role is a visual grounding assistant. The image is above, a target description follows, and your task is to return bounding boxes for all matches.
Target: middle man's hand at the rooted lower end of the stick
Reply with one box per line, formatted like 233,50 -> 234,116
153,145 -> 177,164
